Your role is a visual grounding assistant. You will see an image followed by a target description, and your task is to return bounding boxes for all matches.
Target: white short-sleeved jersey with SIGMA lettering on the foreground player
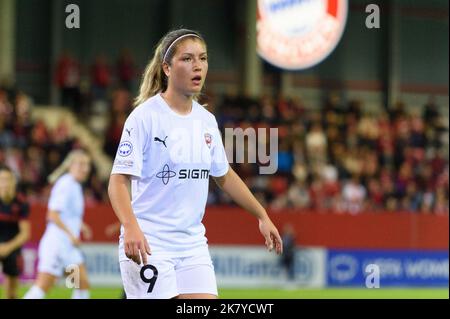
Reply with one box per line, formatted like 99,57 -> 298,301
111,94 -> 229,260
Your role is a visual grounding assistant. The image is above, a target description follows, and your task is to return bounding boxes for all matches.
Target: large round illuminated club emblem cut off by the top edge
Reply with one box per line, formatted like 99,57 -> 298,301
256,0 -> 348,70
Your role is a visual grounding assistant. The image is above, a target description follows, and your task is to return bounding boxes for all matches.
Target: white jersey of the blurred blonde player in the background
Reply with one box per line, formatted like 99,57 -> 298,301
45,173 -> 84,241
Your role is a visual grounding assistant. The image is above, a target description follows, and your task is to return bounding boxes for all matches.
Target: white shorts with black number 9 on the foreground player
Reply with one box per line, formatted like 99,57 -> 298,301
120,251 -> 218,299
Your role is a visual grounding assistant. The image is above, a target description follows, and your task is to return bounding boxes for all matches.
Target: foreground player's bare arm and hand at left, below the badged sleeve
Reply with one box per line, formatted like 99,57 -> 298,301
108,174 -> 151,265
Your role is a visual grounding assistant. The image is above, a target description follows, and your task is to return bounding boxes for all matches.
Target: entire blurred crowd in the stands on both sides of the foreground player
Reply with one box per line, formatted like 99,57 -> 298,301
0,77 -> 449,214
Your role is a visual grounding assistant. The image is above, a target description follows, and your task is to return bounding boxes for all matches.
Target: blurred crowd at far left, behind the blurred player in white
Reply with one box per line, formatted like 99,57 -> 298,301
0,87 -> 107,204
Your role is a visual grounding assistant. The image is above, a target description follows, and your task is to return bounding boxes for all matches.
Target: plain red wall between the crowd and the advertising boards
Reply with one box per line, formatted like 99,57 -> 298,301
26,205 -> 449,249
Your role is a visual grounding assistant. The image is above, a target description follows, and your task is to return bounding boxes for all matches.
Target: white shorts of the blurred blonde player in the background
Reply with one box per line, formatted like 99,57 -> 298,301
38,234 -> 84,277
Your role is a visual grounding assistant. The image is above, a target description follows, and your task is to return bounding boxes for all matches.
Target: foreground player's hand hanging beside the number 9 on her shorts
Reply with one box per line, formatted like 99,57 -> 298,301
123,224 -> 152,265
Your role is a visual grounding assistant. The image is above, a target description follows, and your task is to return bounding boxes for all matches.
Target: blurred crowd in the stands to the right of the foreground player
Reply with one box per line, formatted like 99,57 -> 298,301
209,94 -> 449,214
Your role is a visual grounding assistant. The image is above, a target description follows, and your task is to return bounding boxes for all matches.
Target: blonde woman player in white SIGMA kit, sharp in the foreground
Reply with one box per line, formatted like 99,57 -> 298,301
108,29 -> 282,298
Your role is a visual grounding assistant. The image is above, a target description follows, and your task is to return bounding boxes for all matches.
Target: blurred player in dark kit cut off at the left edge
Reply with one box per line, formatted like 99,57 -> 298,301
0,166 -> 30,299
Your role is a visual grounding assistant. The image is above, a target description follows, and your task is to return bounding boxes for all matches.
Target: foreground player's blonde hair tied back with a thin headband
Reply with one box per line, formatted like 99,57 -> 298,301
134,29 -> 206,106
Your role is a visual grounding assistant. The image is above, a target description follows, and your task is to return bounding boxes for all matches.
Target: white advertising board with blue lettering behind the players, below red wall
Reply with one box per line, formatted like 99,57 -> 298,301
0,243 -> 326,288
